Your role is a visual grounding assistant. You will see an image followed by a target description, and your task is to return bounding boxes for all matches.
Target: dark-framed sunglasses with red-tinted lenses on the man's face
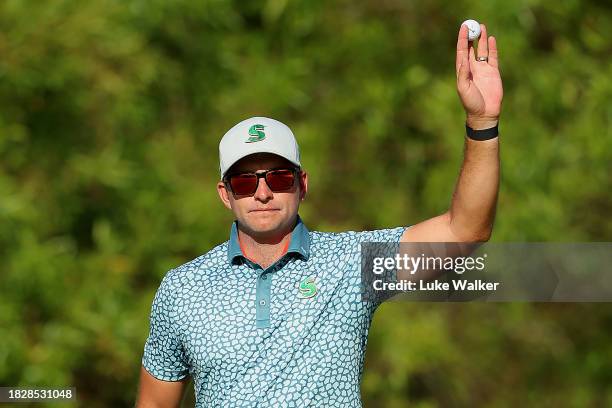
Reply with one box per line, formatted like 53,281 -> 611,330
223,169 -> 298,195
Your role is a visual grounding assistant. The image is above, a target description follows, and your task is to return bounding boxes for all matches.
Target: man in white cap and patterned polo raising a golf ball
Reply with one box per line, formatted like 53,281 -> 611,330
137,25 -> 502,408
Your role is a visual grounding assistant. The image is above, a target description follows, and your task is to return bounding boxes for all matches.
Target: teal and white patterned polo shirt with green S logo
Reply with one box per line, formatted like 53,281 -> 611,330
142,217 -> 405,407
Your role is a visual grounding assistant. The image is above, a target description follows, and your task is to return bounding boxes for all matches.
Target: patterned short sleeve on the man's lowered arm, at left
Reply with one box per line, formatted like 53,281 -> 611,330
142,271 -> 189,381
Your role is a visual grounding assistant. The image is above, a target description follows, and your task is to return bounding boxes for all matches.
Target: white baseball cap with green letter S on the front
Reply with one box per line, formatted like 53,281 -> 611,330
219,116 -> 302,177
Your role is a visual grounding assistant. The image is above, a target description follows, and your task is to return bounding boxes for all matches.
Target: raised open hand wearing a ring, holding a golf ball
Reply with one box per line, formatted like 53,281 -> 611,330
455,24 -> 504,129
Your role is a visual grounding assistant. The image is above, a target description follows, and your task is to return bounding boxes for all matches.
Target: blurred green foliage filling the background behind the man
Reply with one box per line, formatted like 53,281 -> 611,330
0,0 -> 612,408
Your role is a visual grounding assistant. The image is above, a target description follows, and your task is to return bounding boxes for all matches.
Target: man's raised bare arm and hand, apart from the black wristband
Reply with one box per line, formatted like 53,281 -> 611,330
401,24 -> 503,242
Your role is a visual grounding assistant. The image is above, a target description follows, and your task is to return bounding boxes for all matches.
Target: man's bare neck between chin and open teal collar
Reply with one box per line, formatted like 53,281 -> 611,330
238,224 -> 295,269
